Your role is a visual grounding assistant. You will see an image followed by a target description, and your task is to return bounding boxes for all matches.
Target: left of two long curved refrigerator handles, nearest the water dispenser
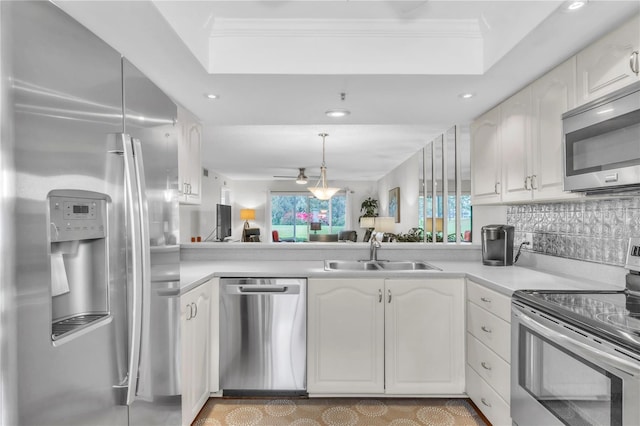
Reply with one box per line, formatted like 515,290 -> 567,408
119,133 -> 144,405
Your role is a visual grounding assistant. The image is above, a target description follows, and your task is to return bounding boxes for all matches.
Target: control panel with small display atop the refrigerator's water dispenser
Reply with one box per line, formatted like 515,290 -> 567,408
49,196 -> 107,242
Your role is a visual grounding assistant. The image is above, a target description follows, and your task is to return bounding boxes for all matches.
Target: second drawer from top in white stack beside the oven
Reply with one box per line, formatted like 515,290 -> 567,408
467,303 -> 511,362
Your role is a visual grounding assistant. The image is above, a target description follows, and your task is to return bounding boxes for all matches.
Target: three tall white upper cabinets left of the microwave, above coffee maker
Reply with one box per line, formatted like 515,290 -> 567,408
471,58 -> 577,205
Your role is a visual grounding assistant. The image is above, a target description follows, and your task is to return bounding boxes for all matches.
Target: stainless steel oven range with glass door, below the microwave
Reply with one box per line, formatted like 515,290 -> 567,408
511,292 -> 640,426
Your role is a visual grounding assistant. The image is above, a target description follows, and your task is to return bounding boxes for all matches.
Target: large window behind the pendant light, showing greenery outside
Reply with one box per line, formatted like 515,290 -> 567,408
271,192 -> 347,241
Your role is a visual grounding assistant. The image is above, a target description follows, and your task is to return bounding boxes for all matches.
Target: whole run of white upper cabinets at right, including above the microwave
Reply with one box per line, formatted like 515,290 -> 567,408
471,16 -> 640,205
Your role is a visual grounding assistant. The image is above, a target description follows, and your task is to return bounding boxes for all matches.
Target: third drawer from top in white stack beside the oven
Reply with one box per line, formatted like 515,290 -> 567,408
467,333 -> 511,401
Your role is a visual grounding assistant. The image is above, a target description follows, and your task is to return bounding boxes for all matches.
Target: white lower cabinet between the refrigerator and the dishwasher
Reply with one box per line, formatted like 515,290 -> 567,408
180,281 -> 211,425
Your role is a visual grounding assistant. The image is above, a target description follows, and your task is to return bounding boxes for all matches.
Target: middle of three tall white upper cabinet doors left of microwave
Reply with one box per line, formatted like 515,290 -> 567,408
500,87 -> 533,201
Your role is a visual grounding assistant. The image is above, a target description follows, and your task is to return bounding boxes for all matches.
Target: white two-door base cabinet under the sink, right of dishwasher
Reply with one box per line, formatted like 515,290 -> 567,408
307,279 -> 464,395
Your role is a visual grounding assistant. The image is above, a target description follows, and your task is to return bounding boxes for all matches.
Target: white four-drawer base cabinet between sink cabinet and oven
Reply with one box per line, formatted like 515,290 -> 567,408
466,280 -> 511,425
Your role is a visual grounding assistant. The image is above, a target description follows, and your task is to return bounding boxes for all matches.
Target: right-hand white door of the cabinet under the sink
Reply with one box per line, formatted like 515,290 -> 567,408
385,279 -> 465,395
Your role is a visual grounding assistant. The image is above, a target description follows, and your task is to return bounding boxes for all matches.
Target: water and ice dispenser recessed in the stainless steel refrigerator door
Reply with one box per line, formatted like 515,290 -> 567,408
48,190 -> 109,341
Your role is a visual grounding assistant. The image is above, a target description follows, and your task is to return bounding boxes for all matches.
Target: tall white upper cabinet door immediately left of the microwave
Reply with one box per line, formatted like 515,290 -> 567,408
531,57 -> 575,200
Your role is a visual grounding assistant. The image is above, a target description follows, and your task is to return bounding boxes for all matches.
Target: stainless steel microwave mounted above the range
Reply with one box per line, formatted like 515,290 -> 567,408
562,82 -> 640,192
